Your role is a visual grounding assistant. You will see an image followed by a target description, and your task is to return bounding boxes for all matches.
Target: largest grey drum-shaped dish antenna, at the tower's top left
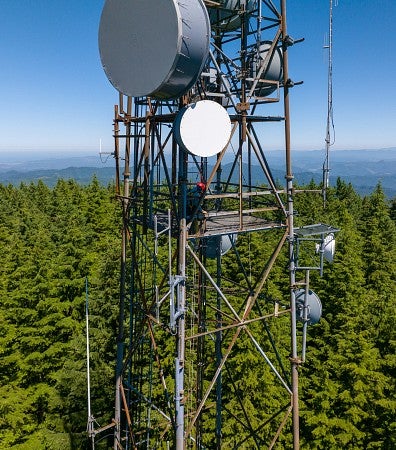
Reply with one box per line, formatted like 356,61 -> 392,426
99,0 -> 210,99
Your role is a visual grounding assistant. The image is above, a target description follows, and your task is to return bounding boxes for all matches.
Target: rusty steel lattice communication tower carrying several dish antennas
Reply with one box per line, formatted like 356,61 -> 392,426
99,0 -> 336,450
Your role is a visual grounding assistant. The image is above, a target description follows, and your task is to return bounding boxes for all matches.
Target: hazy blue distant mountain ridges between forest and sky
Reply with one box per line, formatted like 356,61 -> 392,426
0,147 -> 396,198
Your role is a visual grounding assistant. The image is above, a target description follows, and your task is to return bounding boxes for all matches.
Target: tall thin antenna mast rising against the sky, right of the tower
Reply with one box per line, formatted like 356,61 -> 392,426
323,0 -> 335,205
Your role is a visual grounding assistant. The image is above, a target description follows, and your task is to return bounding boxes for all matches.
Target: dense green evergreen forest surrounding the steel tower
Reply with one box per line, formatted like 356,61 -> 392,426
0,178 -> 396,450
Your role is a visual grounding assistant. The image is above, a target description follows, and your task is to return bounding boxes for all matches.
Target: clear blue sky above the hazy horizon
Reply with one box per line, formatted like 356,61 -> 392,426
0,0 -> 396,155
